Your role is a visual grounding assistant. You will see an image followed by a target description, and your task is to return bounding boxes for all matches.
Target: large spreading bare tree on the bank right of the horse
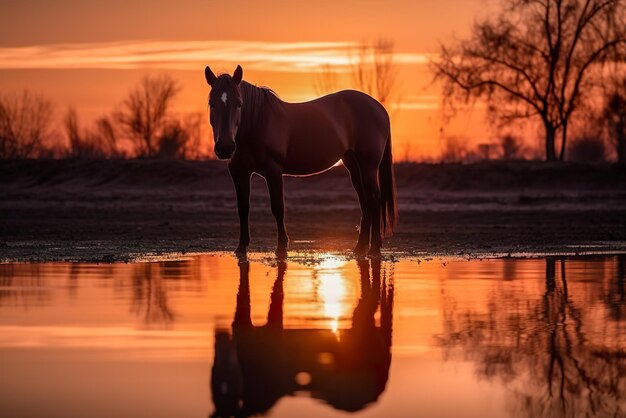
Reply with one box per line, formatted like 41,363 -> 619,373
432,0 -> 626,161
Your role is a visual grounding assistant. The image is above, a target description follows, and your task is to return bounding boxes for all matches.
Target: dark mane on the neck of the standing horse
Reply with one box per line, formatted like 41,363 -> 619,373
237,80 -> 282,139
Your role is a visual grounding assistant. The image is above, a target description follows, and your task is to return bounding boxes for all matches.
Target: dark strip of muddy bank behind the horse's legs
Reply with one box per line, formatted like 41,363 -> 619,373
0,160 -> 626,261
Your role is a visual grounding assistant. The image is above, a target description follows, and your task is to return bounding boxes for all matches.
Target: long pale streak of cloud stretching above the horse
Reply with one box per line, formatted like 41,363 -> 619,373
0,41 -> 429,72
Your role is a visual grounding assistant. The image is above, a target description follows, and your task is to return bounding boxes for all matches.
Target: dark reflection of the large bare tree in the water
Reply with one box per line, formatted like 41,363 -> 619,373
439,256 -> 626,417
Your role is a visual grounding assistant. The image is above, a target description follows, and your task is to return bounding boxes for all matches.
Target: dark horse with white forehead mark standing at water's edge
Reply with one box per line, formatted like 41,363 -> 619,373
204,65 -> 397,258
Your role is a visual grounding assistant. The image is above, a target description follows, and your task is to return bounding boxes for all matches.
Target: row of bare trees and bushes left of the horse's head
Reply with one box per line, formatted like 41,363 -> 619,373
0,75 -> 213,159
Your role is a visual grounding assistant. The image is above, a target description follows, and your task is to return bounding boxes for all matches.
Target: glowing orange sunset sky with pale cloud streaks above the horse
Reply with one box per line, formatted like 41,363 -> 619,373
0,0 -> 497,158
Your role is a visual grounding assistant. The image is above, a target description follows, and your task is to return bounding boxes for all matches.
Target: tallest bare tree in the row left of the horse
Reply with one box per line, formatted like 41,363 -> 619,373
116,74 -> 180,157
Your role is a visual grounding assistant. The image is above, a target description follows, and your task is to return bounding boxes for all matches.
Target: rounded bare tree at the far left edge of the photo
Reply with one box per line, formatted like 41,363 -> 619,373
0,91 -> 54,158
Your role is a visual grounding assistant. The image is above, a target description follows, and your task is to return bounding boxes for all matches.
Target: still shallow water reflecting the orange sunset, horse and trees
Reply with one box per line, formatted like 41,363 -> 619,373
0,255 -> 626,417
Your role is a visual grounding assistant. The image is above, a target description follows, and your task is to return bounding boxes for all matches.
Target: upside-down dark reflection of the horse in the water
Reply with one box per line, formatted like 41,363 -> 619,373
211,260 -> 393,417
